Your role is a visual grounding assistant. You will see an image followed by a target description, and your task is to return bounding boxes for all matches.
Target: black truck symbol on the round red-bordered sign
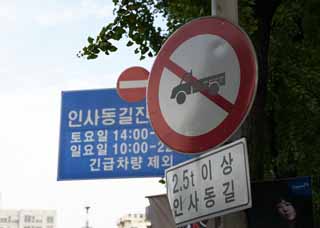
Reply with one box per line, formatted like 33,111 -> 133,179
170,70 -> 226,104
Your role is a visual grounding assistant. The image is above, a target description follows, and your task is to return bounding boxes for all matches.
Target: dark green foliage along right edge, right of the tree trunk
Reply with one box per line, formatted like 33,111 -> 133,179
268,0 -> 320,176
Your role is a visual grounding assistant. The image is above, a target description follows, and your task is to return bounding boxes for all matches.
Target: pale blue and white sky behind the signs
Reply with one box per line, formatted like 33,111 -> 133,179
0,0 -> 165,228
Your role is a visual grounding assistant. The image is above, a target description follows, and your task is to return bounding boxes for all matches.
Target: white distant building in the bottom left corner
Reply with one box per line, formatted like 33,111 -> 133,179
0,210 -> 56,228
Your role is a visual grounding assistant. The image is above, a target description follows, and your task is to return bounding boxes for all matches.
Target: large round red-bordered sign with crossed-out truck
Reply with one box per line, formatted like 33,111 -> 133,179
147,17 -> 257,153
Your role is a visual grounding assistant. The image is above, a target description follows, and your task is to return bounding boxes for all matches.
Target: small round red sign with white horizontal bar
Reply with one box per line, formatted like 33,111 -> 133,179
117,66 -> 149,102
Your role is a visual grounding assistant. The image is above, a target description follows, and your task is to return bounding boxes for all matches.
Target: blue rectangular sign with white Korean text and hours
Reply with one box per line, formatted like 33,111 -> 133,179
58,89 -> 194,180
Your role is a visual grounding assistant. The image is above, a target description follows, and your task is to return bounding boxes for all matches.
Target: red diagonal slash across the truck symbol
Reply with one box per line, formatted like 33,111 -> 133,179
165,59 -> 233,113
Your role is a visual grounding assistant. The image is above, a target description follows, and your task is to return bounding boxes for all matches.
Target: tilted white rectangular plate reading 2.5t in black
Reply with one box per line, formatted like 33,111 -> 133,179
166,139 -> 251,226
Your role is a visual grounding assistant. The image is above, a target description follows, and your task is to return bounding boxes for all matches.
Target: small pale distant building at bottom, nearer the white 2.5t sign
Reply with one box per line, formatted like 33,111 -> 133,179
117,213 -> 151,228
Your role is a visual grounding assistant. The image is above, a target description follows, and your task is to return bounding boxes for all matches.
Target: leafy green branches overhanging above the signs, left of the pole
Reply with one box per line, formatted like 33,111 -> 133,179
78,0 -> 210,59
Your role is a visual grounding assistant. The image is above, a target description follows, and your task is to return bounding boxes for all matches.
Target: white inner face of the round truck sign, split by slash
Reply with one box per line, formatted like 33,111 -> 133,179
159,34 -> 240,136
